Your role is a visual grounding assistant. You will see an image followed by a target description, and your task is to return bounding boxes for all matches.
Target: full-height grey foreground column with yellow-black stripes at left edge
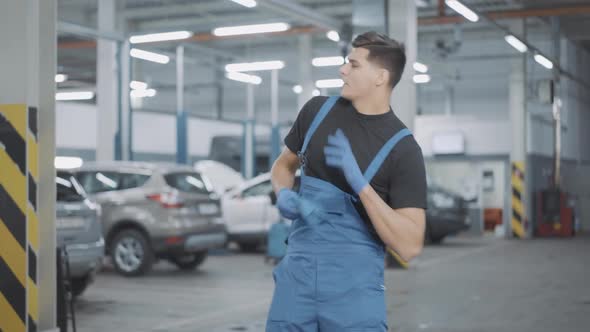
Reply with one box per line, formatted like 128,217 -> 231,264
0,0 -> 57,332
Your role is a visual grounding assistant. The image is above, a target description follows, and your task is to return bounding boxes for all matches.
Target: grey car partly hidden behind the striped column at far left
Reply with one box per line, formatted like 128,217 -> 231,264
55,171 -> 104,296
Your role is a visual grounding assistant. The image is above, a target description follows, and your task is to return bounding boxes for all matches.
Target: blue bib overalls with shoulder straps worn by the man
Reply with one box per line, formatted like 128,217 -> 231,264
266,97 -> 411,332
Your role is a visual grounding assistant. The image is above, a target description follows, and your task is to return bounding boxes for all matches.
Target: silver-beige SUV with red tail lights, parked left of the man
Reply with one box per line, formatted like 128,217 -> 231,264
75,161 -> 227,276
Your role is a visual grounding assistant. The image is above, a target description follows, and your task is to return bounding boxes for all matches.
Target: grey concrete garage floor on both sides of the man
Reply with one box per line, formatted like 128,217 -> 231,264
76,236 -> 590,332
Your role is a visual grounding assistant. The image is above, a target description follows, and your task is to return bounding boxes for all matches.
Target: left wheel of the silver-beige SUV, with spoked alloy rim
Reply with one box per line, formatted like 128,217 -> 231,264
110,229 -> 154,277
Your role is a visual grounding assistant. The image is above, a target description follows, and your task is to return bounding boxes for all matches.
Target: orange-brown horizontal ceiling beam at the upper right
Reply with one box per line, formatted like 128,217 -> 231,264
418,6 -> 590,25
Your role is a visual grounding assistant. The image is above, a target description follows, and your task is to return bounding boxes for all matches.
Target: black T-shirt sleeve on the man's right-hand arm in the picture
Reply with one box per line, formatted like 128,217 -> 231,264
389,145 -> 427,209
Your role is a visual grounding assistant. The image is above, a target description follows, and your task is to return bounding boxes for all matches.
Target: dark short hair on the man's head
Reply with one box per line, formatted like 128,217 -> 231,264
352,31 -> 406,89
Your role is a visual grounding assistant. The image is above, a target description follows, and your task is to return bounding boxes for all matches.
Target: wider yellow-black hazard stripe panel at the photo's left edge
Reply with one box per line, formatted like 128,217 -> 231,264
0,105 -> 28,332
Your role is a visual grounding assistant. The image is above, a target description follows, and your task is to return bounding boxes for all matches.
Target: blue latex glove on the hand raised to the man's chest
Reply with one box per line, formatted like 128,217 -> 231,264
324,129 -> 369,194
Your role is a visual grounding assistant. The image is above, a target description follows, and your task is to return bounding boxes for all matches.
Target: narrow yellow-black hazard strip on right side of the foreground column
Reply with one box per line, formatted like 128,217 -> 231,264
27,107 -> 39,332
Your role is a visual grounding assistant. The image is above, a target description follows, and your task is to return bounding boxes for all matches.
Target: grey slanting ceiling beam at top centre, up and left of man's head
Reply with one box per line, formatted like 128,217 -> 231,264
258,0 -> 344,31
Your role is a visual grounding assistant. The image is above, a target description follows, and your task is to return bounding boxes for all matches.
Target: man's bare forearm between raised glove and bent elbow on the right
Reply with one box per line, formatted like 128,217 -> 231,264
359,186 -> 424,261
